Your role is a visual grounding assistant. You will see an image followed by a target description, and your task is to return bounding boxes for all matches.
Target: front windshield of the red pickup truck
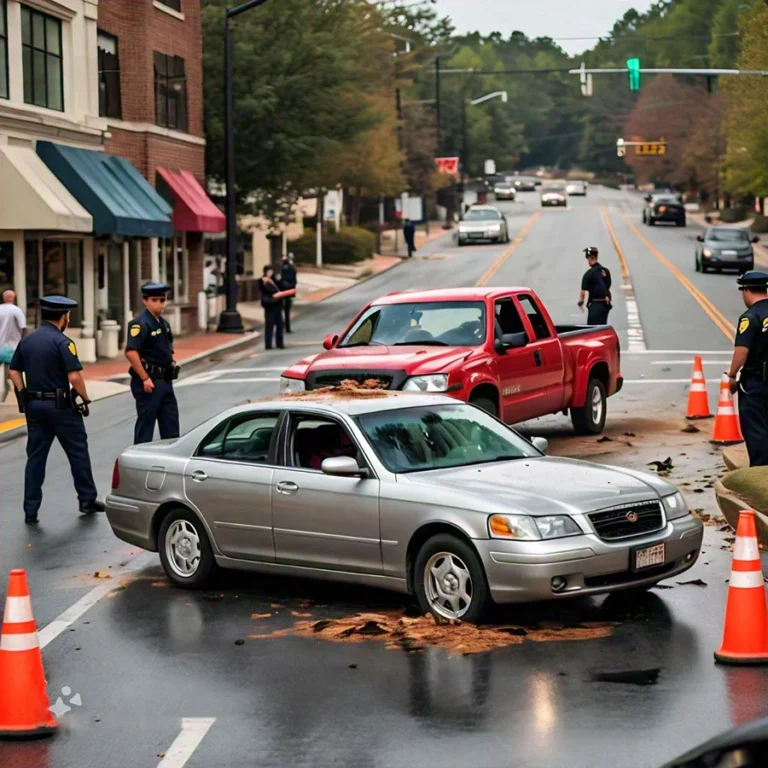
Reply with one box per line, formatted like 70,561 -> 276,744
339,301 -> 486,347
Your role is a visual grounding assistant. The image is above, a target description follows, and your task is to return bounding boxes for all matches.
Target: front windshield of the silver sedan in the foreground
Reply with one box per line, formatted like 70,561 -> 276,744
358,403 -> 541,473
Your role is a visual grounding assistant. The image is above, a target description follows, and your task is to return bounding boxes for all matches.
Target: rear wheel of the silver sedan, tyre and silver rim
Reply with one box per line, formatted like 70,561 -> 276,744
157,507 -> 217,589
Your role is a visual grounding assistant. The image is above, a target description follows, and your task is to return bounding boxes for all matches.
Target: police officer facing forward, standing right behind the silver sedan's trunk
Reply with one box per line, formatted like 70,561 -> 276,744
125,283 -> 179,444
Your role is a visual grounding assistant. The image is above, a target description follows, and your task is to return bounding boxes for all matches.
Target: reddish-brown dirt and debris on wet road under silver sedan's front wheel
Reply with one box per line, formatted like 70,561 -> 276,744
250,610 -> 617,654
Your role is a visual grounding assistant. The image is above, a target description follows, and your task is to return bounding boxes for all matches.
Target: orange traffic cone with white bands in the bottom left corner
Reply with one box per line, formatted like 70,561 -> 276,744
0,569 -> 58,738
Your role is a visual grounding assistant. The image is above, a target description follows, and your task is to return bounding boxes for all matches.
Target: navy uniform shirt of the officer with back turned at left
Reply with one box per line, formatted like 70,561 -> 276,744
11,321 -> 83,392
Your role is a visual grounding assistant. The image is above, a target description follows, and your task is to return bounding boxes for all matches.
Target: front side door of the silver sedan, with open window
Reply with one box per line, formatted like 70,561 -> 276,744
272,410 -> 382,573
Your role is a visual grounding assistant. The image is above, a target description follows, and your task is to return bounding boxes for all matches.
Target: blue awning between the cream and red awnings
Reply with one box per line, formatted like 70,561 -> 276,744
37,141 -> 173,237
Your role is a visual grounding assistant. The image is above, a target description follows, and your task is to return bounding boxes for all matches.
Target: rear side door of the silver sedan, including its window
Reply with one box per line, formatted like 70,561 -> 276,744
184,410 -> 281,562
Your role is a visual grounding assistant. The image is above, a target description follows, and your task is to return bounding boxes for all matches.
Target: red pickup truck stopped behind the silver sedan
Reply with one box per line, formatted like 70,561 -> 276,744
280,288 -> 623,434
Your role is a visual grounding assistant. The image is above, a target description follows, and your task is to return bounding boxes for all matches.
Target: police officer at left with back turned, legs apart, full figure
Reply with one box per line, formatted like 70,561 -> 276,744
10,296 -> 104,524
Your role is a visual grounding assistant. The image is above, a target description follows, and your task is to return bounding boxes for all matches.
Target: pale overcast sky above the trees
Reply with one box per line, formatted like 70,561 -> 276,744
435,0 -> 652,54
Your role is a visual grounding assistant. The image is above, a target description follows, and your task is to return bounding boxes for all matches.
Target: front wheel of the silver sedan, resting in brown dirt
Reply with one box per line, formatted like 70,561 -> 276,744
413,533 -> 490,624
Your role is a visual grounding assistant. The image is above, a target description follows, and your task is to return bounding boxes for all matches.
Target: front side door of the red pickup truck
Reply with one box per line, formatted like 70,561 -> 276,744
493,296 -> 543,424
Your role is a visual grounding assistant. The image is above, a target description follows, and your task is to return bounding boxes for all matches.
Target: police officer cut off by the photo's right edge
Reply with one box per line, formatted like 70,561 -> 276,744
728,270 -> 768,467
